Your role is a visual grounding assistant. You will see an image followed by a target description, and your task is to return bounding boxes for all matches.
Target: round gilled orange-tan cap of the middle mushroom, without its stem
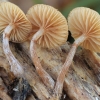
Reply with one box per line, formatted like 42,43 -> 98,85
26,4 -> 68,48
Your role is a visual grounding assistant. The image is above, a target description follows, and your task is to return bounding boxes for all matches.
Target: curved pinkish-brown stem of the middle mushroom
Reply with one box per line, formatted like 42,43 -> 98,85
30,29 -> 55,89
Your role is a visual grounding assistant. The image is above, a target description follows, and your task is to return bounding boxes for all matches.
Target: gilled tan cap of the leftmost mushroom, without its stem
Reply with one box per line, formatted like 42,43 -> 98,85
0,2 -> 32,42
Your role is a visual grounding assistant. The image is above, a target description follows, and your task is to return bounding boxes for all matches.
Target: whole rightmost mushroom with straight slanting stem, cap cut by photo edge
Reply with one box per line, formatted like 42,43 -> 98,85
54,7 -> 100,98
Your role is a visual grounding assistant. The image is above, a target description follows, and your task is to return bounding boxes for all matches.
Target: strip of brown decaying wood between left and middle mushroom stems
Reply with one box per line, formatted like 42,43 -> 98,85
1,40 -> 49,100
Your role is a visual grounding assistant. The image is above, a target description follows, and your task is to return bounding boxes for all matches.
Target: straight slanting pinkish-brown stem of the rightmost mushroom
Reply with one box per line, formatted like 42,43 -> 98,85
54,35 -> 86,98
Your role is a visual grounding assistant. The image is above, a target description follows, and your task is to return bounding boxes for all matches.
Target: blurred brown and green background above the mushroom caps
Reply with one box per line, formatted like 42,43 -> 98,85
9,0 -> 100,17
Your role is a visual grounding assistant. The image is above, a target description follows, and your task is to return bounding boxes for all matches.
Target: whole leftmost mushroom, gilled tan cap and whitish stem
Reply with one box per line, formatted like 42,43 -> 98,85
0,2 -> 32,77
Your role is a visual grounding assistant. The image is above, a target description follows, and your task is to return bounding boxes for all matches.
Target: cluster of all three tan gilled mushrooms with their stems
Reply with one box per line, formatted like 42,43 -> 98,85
0,2 -> 100,100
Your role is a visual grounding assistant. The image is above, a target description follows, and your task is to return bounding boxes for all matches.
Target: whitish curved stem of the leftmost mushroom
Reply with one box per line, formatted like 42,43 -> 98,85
3,25 -> 24,77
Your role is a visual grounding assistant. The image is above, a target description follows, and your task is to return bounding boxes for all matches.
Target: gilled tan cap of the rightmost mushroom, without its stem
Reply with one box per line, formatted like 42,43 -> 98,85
68,7 -> 100,52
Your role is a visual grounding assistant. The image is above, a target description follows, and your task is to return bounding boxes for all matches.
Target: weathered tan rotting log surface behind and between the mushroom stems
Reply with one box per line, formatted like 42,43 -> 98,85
0,27 -> 100,100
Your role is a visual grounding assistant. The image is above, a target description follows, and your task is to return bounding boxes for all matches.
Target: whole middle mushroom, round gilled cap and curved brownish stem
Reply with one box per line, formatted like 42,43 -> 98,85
26,4 -> 68,89
